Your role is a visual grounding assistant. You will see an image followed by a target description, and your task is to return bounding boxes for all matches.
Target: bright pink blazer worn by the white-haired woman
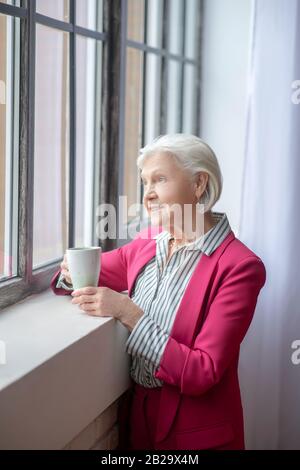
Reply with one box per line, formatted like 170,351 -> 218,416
51,231 -> 266,449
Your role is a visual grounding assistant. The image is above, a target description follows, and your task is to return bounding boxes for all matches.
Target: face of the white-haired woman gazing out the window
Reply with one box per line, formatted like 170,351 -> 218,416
141,152 -> 204,227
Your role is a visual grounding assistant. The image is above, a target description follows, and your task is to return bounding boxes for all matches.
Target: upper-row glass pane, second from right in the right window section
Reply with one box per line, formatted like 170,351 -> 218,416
167,0 -> 184,55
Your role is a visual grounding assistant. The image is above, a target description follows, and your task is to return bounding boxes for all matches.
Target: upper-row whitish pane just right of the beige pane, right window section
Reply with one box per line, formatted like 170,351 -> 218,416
146,0 -> 164,48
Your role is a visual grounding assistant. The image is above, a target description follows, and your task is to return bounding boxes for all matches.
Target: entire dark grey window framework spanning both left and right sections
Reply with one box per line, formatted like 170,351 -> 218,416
0,0 -> 203,311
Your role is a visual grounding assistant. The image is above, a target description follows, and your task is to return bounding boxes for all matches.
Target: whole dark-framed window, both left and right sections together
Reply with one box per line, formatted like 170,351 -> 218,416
0,0 -> 202,308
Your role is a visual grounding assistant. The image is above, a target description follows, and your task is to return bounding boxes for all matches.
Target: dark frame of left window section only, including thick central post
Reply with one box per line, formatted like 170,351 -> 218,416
0,0 -> 123,310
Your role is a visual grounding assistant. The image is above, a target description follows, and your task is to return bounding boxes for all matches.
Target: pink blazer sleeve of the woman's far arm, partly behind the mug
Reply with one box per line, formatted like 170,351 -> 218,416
50,245 -> 128,295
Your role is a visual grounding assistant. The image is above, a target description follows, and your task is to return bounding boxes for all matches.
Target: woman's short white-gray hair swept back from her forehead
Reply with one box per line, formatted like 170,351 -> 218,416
137,134 -> 223,212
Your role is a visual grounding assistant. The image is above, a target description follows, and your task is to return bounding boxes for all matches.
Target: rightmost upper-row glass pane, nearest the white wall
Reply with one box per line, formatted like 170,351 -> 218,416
184,0 -> 200,60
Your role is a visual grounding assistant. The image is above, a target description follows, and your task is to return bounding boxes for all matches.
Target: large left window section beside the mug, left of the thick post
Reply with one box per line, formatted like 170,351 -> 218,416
0,0 -> 106,308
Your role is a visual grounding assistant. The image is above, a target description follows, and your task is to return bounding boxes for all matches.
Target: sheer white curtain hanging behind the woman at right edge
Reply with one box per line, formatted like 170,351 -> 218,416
239,0 -> 300,449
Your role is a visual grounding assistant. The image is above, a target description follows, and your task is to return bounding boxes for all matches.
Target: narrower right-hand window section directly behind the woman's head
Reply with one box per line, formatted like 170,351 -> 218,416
120,0 -> 202,215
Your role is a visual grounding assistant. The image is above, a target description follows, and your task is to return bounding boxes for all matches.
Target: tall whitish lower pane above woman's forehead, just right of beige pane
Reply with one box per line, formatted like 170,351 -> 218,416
144,54 -> 161,144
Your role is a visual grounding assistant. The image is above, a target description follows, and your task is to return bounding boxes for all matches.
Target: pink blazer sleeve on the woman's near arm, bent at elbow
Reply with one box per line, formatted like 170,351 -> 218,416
155,256 -> 266,396
